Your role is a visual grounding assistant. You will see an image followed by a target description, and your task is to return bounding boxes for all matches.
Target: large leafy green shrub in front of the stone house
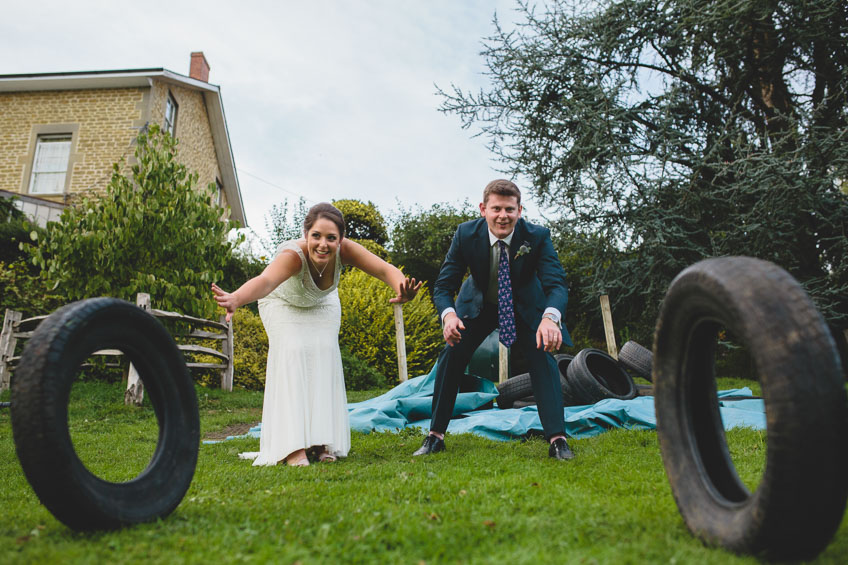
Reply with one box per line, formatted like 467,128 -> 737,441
27,125 -> 240,318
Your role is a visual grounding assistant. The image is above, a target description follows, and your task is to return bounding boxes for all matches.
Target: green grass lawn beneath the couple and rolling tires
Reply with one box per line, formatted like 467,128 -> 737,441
0,381 -> 848,565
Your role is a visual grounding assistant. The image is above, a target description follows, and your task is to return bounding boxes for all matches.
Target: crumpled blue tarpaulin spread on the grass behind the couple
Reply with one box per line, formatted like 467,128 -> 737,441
210,366 -> 766,441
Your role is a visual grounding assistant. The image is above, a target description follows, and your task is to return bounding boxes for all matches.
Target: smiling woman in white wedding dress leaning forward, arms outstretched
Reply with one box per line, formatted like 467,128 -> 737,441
212,203 -> 421,466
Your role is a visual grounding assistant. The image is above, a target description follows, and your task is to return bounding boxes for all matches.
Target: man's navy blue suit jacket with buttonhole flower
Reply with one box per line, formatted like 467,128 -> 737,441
433,218 -> 573,346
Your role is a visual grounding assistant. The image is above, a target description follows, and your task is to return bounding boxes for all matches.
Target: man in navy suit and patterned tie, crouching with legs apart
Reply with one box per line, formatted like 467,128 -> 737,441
413,180 -> 574,459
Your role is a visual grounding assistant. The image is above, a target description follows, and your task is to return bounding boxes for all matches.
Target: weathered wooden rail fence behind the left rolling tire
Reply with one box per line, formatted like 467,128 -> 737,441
0,292 -> 233,404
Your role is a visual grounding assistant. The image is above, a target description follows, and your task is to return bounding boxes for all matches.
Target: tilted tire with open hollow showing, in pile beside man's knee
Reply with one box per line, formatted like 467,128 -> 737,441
567,349 -> 636,404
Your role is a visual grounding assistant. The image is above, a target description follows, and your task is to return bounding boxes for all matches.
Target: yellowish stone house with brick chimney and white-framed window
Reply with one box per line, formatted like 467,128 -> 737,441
0,52 -> 247,227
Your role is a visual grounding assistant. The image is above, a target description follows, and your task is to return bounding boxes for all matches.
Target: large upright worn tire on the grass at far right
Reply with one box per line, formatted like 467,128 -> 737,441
654,257 -> 848,560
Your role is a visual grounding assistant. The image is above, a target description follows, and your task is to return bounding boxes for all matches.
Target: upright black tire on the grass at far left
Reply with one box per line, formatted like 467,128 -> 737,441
11,298 -> 200,530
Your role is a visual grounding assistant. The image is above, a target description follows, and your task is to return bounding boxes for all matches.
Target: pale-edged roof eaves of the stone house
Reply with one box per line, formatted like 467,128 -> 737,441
0,69 -> 247,227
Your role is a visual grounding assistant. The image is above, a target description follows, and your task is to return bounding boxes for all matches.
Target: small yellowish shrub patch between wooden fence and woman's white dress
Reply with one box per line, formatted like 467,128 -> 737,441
233,308 -> 268,390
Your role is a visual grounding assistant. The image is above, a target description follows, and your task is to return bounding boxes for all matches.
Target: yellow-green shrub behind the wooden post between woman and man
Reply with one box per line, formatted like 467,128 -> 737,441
339,269 -> 443,384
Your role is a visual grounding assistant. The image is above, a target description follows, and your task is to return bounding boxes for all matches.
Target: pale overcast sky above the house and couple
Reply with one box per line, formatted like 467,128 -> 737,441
0,0 -> 518,242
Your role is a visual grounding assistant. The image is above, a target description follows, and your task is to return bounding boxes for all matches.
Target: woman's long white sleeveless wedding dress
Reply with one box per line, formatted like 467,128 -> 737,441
240,240 -> 350,465
